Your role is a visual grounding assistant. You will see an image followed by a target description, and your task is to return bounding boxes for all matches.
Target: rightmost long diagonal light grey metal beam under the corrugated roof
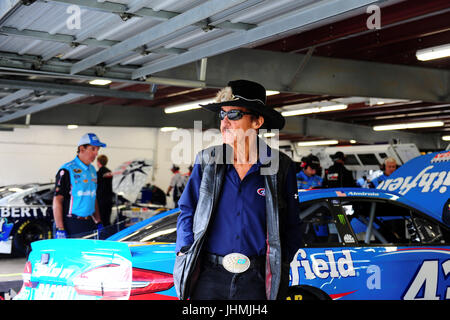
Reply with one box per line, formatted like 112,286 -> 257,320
132,0 -> 378,79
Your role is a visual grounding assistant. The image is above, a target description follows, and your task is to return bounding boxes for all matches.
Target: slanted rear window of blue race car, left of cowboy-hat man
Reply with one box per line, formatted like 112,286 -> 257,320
118,211 -> 180,242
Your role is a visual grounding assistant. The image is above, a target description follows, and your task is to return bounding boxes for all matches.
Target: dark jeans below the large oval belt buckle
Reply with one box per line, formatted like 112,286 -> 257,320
191,261 -> 266,300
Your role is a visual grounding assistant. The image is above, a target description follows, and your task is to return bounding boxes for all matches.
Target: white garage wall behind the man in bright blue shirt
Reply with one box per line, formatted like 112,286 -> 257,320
0,126 -> 221,206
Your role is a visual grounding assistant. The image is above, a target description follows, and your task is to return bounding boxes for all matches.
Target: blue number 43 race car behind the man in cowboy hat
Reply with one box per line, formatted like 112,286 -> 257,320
16,152 -> 450,300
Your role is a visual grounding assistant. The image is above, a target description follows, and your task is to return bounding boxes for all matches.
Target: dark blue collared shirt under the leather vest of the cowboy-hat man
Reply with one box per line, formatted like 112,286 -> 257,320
175,148 -> 300,257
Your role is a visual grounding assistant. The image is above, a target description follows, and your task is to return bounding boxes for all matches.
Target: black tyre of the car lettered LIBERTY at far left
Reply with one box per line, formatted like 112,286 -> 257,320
12,220 -> 53,257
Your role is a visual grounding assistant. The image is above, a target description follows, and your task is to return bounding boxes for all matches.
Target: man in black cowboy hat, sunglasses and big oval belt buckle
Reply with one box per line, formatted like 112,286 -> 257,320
174,80 -> 301,300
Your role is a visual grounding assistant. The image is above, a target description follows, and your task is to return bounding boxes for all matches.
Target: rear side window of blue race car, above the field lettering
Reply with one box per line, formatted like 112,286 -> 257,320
300,201 -> 341,246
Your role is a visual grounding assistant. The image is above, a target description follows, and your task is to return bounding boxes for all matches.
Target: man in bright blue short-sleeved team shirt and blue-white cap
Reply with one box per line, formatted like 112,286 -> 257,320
53,133 -> 106,239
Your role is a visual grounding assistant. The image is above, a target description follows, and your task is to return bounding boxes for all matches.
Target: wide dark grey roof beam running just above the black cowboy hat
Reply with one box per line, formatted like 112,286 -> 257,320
155,48 -> 450,103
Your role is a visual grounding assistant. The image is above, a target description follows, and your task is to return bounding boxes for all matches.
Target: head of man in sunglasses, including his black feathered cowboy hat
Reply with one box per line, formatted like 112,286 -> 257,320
202,80 -> 285,145
